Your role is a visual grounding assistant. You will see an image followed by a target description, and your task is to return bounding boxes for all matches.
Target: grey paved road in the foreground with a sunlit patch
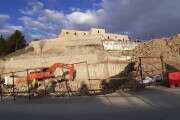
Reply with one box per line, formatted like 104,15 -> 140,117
0,87 -> 180,120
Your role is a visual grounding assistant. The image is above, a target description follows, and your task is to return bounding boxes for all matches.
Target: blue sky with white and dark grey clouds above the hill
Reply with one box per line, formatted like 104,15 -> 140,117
0,0 -> 180,40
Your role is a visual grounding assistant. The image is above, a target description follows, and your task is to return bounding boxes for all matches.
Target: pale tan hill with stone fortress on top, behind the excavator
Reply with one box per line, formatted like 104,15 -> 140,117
0,28 -> 137,90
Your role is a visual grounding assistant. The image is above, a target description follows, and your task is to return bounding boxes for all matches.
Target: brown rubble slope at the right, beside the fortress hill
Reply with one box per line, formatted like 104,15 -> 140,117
133,35 -> 180,70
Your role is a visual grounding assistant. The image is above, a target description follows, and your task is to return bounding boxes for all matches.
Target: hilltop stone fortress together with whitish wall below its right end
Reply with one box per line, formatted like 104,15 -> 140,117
30,28 -> 135,53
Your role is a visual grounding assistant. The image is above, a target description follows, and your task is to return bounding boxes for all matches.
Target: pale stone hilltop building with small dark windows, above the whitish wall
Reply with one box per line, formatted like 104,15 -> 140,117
30,28 -> 129,54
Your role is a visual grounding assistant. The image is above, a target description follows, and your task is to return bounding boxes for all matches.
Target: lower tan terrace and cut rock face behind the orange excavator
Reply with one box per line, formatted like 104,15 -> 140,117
1,54 -> 128,90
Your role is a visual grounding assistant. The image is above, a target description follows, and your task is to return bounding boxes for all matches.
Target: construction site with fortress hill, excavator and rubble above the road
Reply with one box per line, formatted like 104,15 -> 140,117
0,28 -> 180,101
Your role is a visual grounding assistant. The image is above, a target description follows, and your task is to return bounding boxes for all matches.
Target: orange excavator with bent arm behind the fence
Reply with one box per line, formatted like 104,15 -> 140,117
27,63 -> 76,87
